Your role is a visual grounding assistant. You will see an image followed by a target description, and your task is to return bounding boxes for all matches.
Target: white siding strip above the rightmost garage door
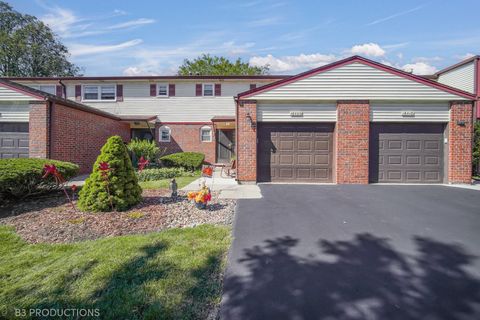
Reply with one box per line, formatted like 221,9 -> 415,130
370,103 -> 450,122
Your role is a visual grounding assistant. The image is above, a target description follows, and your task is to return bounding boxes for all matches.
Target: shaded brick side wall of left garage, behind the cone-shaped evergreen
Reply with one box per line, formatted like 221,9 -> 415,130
48,103 -> 130,173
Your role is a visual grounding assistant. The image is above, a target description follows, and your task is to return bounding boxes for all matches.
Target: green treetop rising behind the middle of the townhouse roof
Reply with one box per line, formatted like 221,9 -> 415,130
178,54 -> 269,76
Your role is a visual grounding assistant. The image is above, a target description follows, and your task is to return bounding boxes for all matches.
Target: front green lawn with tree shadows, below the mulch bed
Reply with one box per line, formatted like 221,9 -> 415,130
0,225 -> 231,319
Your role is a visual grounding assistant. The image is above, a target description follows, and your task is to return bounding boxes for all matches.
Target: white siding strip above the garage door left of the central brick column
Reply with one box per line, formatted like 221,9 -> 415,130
257,102 -> 337,122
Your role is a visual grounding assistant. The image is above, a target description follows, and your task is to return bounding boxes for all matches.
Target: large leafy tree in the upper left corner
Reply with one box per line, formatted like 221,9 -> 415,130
0,1 -> 80,77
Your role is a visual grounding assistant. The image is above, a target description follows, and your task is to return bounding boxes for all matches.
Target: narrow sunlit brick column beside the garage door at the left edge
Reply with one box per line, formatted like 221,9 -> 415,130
28,102 -> 50,158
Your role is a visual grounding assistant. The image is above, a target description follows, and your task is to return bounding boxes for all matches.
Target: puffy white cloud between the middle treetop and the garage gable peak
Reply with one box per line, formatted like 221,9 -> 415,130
249,53 -> 338,72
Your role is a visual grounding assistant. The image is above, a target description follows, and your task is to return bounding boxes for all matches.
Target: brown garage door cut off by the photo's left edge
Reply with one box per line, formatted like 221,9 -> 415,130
0,122 -> 28,158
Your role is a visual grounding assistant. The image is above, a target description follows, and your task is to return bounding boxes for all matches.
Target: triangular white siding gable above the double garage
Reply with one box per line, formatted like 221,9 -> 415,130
249,62 -> 467,101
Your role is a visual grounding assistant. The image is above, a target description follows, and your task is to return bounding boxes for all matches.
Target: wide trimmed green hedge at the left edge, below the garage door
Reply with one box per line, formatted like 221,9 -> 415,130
0,158 -> 79,198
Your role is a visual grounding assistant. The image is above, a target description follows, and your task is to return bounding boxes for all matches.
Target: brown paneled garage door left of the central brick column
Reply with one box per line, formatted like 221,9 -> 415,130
257,123 -> 333,182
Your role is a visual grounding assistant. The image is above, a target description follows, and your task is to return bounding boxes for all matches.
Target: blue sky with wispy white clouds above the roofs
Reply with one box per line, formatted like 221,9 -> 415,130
9,0 -> 480,75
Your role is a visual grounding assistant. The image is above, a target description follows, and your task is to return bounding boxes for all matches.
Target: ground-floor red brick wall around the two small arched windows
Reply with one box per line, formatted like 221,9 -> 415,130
155,123 -> 215,163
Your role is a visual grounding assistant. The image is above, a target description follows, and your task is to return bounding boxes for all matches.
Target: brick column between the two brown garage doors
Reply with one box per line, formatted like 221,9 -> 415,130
335,101 -> 370,184
